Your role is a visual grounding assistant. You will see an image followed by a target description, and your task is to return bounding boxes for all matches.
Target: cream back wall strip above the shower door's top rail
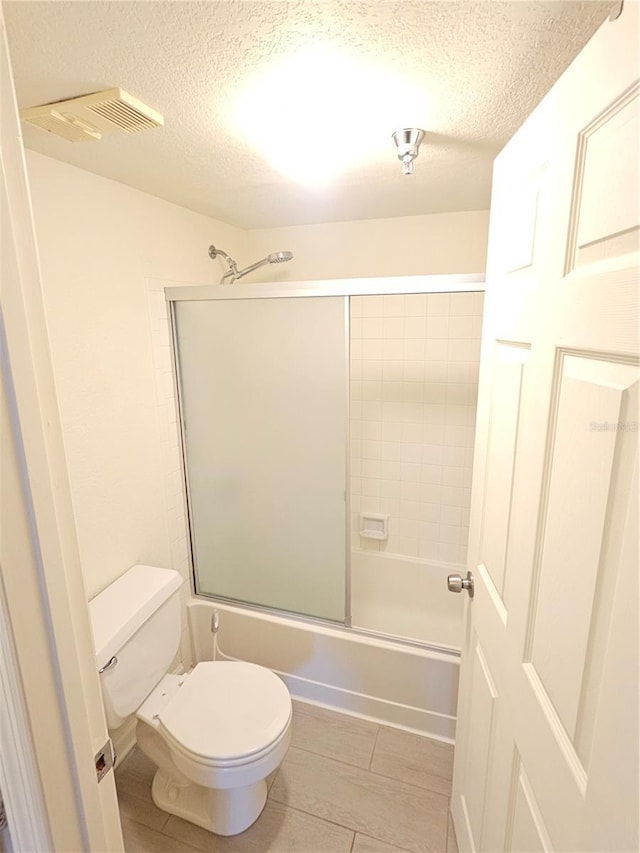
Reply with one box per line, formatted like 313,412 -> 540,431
249,210 -> 489,281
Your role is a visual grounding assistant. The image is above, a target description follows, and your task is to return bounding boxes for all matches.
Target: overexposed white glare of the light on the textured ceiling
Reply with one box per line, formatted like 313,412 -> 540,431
233,44 -> 423,187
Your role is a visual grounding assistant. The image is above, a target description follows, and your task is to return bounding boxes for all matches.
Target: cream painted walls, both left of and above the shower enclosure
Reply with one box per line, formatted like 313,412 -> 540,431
22,151 -> 488,660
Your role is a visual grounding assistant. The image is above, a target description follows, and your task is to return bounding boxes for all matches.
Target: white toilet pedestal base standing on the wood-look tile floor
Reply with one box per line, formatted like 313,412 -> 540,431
151,769 -> 267,835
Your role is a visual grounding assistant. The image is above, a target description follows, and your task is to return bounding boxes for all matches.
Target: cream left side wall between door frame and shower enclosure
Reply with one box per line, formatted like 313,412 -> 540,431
27,151 -> 247,624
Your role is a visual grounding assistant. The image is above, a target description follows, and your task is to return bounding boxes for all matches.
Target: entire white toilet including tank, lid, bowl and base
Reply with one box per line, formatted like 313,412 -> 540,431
89,566 -> 292,835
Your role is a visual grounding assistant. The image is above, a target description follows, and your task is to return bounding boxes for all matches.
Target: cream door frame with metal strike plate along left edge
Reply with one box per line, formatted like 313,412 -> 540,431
0,9 -> 123,851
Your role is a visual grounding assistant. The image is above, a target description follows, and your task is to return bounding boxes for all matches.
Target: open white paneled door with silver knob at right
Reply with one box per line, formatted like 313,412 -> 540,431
452,8 -> 640,853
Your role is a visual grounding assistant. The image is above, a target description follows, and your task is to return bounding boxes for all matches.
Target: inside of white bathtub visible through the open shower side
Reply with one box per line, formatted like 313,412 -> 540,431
351,549 -> 465,652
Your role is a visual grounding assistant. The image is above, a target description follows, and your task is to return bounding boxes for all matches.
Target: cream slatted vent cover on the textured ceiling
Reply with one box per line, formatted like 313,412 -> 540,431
20,89 -> 164,142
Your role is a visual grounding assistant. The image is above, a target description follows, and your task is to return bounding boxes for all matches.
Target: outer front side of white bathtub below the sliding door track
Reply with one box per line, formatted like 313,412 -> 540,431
187,598 -> 459,742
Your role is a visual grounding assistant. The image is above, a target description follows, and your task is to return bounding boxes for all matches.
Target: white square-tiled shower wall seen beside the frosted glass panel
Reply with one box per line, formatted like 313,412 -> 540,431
350,293 -> 483,564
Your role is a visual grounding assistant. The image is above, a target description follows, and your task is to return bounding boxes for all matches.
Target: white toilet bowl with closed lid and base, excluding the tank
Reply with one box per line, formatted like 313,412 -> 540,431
136,661 -> 291,835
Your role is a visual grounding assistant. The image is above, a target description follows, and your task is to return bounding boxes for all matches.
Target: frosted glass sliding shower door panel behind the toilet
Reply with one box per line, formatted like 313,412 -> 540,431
174,297 -> 348,622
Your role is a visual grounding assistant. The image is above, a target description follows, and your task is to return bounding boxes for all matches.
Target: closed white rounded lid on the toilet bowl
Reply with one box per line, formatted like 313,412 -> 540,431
158,661 -> 291,760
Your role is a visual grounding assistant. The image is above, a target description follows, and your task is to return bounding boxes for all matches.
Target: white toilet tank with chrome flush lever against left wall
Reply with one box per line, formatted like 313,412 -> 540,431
89,566 -> 183,729
